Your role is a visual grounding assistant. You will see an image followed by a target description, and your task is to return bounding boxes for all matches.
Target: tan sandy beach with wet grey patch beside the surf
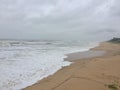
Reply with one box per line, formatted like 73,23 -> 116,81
24,42 -> 120,90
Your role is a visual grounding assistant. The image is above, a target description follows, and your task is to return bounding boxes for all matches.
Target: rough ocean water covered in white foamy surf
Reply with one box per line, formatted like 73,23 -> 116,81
0,40 -> 97,90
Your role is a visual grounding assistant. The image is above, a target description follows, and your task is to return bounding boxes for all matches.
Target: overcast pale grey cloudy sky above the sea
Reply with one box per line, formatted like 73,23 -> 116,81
0,0 -> 120,40
